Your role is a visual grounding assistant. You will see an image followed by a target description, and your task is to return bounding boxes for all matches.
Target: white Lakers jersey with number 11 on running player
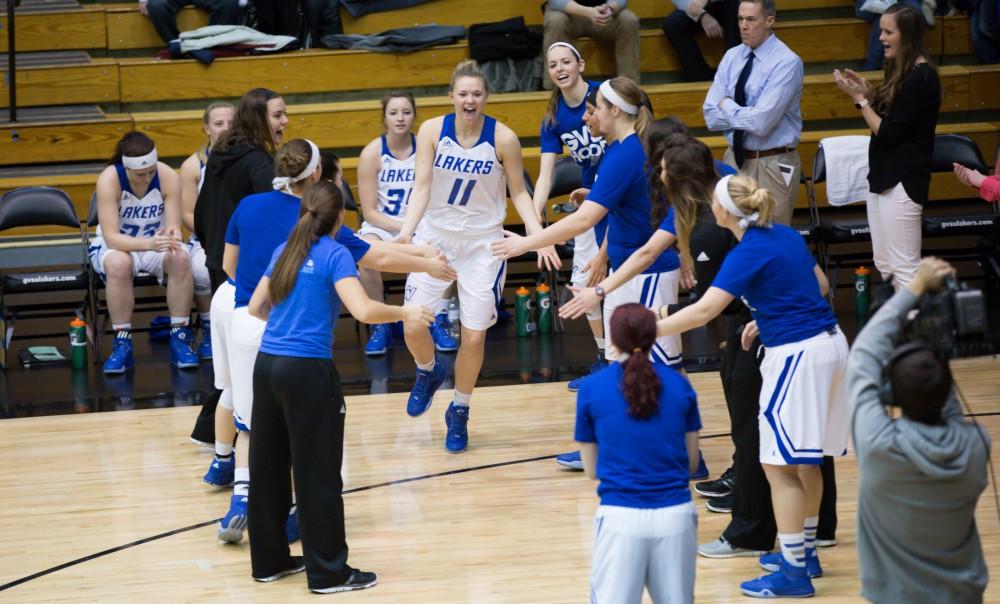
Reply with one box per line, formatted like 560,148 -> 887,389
424,113 -> 507,238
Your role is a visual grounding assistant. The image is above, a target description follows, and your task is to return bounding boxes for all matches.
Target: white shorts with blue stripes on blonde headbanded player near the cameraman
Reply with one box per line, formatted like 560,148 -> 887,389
757,328 -> 851,466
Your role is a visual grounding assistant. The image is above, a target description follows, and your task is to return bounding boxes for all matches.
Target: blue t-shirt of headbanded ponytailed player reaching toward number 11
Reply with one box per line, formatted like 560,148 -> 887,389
587,135 -> 681,273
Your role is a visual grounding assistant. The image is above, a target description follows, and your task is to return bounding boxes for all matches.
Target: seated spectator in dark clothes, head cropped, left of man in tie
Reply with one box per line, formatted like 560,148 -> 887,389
661,0 -> 740,82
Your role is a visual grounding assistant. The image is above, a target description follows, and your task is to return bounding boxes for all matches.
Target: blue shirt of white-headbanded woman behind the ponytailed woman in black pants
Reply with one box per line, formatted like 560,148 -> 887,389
226,191 -> 371,308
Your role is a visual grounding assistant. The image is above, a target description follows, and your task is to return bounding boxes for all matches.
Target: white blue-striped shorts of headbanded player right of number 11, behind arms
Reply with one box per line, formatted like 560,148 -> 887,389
604,269 -> 684,367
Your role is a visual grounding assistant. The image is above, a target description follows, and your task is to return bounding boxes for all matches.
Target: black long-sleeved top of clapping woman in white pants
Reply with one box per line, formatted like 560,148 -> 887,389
868,63 -> 941,204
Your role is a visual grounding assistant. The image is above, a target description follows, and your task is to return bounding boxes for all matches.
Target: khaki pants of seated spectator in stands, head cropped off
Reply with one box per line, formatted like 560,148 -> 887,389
542,9 -> 639,90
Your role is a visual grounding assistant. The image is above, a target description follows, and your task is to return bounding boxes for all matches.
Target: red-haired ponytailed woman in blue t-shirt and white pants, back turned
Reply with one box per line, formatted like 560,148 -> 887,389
575,303 -> 701,603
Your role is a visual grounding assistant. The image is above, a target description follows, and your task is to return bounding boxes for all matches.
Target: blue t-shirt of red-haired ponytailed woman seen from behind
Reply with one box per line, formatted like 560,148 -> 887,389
575,363 -> 701,508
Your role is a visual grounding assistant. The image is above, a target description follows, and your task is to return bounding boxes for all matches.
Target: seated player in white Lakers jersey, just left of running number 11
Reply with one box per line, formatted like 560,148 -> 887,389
358,92 -> 458,356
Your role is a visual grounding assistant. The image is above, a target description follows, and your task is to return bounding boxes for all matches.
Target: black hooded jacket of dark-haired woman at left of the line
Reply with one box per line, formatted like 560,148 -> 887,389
194,143 -> 274,270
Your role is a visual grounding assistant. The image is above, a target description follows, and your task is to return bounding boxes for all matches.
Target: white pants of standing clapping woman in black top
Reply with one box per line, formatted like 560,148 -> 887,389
868,183 -> 924,289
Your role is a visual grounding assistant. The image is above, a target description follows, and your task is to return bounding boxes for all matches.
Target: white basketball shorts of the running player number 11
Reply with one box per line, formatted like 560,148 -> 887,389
404,225 -> 507,330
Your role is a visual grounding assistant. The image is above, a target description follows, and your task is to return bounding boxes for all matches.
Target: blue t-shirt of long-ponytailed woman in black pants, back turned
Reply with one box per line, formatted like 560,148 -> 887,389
260,237 -> 358,359
